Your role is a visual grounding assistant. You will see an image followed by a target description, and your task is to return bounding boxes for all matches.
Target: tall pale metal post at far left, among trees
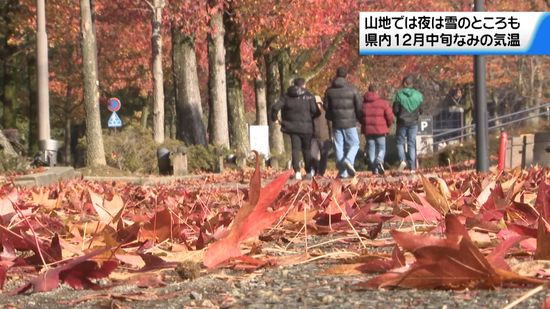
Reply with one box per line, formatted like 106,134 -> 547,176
36,0 -> 50,141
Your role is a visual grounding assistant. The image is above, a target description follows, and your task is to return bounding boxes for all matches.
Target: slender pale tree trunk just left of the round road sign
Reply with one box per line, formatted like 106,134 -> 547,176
80,0 -> 107,166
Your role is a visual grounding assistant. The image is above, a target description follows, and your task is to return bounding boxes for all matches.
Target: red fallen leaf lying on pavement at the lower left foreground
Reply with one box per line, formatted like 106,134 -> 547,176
16,248 -> 116,294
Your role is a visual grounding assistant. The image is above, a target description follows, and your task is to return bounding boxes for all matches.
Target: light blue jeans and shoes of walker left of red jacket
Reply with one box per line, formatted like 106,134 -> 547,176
334,127 -> 359,178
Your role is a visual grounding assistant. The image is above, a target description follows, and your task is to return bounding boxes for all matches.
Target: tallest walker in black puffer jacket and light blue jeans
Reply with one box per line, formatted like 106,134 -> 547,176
324,67 -> 362,178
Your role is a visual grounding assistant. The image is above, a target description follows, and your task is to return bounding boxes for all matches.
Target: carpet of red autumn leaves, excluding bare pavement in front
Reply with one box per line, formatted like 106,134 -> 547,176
0,161 -> 550,291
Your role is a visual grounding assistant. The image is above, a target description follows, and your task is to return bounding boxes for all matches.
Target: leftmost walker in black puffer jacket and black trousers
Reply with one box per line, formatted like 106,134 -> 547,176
271,78 -> 321,180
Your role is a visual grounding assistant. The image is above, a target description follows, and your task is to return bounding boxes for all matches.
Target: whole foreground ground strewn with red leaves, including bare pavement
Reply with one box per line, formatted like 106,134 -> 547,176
0,160 -> 550,308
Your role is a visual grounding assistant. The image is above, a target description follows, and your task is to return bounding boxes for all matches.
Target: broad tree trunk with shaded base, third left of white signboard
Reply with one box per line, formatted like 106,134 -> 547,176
172,26 -> 206,145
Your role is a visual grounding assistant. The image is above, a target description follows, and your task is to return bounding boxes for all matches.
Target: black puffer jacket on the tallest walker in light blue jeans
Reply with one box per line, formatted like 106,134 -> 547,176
324,77 -> 363,129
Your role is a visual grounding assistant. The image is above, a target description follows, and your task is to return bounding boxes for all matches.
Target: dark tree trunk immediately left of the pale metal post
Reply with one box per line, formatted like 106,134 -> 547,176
27,54 -> 39,155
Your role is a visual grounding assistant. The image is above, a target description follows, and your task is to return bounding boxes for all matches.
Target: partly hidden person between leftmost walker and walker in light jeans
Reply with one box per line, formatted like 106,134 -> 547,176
311,96 -> 332,176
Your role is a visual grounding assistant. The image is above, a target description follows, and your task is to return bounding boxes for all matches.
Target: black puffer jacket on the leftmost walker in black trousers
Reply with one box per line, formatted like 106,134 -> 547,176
271,86 -> 321,134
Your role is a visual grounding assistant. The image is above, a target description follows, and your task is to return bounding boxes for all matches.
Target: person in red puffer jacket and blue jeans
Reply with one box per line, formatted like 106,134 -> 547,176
362,84 -> 394,175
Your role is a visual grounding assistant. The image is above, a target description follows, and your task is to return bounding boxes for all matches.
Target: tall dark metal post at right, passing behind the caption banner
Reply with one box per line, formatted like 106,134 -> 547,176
474,0 -> 489,172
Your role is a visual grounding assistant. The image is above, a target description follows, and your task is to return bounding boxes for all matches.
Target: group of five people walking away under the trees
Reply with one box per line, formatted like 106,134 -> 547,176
270,67 -> 423,179
